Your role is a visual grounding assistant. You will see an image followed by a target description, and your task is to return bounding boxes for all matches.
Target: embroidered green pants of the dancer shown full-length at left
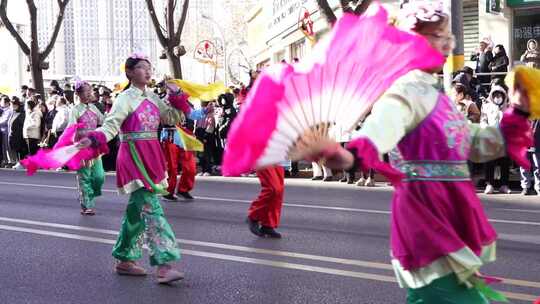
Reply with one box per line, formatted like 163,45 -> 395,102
112,188 -> 180,266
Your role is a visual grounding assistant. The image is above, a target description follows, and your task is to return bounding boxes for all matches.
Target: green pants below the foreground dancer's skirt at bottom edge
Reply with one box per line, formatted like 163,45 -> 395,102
407,274 -> 489,304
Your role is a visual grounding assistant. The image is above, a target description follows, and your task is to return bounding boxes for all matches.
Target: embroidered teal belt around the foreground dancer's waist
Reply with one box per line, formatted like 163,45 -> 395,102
394,161 -> 471,181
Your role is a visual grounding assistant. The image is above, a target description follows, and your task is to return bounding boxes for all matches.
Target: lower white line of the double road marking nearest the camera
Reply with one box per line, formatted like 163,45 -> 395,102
0,225 -> 540,301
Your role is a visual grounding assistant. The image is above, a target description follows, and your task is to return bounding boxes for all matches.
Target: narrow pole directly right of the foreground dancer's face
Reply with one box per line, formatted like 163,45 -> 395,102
444,0 -> 465,92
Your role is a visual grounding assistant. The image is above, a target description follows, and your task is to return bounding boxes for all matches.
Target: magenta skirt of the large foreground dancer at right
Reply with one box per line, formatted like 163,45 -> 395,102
391,181 -> 497,270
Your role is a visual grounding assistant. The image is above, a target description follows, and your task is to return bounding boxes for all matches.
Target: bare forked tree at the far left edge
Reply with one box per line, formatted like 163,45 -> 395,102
0,0 -> 69,96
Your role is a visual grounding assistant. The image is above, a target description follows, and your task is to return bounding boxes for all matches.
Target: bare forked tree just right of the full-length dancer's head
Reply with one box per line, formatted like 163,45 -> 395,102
146,0 -> 189,79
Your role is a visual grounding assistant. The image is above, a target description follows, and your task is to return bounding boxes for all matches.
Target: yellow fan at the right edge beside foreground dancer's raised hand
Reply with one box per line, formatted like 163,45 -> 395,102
506,66 -> 540,119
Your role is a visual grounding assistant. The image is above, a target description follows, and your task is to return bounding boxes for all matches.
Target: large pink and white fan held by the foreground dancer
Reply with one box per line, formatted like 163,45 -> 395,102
222,3 -> 445,175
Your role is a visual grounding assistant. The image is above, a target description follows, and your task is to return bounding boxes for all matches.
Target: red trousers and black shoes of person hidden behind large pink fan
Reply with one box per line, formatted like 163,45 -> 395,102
247,166 -> 285,239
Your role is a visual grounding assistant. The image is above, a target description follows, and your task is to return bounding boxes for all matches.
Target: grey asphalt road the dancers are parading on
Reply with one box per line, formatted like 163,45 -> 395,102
0,170 -> 540,304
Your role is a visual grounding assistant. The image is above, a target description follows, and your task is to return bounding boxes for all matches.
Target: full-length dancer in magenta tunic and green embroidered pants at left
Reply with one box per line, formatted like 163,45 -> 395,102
78,54 -> 191,283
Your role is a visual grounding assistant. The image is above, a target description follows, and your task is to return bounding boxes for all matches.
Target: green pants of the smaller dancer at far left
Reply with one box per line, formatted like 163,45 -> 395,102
77,157 -> 105,209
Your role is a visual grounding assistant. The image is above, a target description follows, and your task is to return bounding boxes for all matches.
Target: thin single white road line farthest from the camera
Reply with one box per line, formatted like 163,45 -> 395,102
0,182 -> 540,226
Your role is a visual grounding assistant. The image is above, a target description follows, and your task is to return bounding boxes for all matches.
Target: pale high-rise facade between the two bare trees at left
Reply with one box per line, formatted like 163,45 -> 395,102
36,0 -> 158,82
